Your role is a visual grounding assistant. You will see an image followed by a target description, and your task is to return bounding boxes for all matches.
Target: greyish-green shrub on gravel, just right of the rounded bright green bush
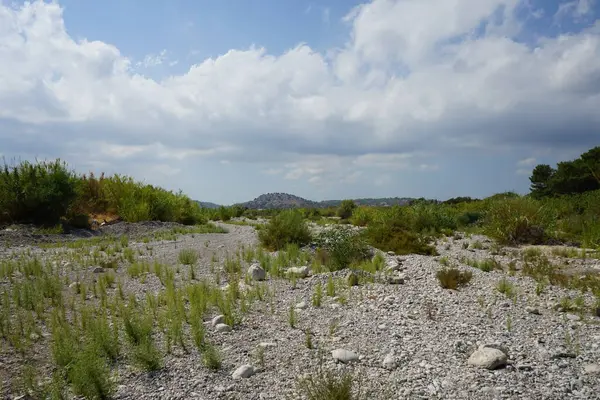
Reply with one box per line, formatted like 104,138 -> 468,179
315,226 -> 369,271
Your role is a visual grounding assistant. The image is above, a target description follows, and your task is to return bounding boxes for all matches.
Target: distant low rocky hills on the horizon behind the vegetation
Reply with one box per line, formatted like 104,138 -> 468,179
234,193 -> 414,209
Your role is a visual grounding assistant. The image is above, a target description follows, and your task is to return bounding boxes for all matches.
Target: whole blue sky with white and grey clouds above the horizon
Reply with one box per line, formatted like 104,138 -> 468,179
0,0 -> 600,204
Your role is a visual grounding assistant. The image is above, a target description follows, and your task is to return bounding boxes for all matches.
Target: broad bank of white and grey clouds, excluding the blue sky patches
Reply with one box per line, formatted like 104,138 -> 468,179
0,0 -> 600,200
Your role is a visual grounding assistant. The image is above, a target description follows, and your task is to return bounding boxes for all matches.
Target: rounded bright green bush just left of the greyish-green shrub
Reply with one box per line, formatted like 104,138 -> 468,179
258,210 -> 311,250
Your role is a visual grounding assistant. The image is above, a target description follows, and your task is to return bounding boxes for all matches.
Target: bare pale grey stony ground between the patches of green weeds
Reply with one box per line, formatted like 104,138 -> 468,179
0,220 -> 600,400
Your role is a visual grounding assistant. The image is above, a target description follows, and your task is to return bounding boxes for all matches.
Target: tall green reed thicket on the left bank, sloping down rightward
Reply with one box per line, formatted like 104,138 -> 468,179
0,160 -> 207,227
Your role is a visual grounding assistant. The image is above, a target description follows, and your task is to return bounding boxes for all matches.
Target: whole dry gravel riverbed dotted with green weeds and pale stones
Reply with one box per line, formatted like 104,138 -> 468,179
0,223 -> 600,400
